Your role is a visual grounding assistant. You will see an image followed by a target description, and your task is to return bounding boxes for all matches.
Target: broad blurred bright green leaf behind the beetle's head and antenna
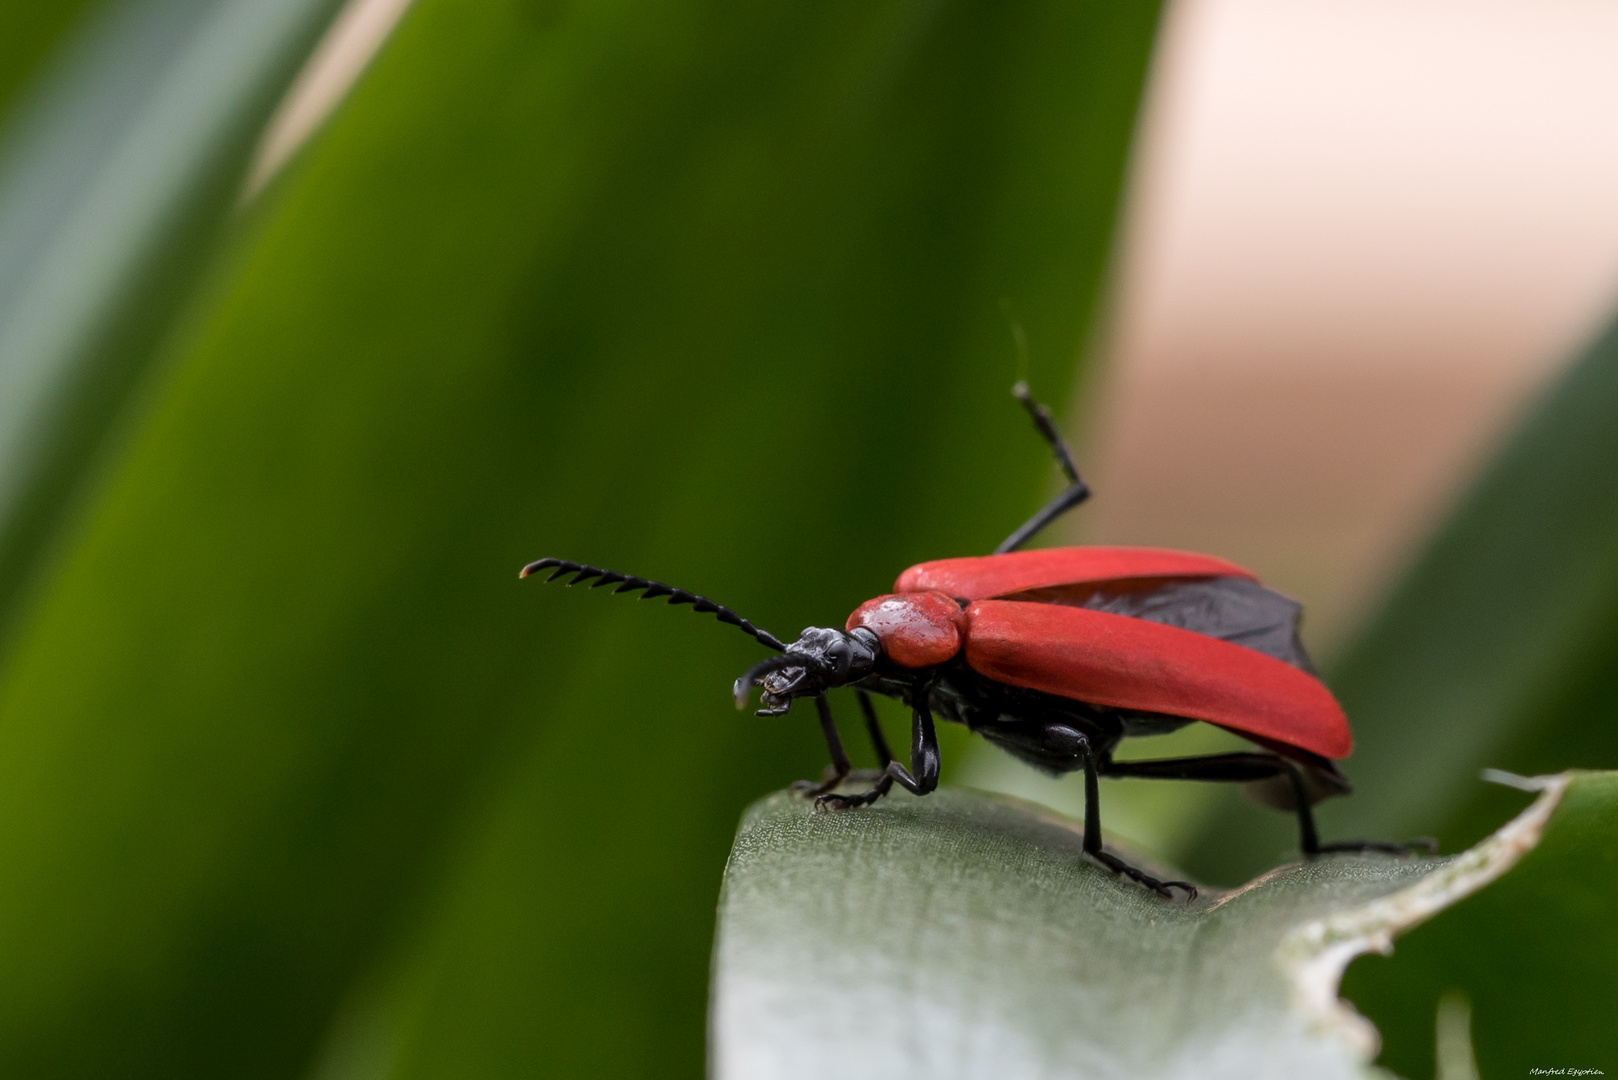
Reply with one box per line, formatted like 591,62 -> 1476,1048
0,0 -> 1157,1077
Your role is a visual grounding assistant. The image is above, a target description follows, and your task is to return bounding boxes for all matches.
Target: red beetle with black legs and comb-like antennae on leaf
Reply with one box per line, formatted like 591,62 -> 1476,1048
521,382 -> 1435,899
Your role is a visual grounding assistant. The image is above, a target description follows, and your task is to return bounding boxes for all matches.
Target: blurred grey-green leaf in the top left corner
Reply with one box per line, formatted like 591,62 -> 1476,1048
0,0 -> 337,633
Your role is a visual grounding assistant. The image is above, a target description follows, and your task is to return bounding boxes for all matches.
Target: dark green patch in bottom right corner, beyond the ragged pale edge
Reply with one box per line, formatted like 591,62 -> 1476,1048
1343,772 -> 1618,1080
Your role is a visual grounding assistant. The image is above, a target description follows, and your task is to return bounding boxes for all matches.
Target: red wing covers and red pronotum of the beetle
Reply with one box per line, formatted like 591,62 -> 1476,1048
873,547 -> 1354,759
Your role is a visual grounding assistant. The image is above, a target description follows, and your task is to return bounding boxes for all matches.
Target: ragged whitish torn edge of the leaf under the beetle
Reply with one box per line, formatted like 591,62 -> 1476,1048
1275,769 -> 1578,1065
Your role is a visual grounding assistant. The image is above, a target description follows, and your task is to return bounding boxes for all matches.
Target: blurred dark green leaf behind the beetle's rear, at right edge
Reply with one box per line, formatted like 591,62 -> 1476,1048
1184,307 -> 1618,881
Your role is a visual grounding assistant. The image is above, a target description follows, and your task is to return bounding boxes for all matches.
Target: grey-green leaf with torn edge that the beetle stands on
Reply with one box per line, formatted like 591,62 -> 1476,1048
712,774 -> 1618,1080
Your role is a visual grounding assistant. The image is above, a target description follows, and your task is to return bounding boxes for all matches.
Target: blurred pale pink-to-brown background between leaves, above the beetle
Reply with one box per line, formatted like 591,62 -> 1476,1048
1074,0 -> 1618,657
